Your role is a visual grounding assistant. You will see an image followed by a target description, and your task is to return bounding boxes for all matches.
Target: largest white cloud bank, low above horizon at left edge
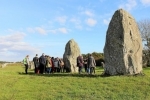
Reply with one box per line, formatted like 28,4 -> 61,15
0,31 -> 40,61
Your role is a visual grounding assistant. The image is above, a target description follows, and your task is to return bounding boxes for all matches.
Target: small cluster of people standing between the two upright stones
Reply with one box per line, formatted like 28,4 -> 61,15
77,54 -> 96,74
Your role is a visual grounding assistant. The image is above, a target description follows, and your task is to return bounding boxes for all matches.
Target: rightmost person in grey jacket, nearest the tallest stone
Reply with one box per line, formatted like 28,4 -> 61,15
88,54 -> 96,74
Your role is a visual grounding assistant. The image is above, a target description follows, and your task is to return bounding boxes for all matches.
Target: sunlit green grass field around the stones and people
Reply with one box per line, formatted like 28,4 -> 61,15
0,64 -> 150,100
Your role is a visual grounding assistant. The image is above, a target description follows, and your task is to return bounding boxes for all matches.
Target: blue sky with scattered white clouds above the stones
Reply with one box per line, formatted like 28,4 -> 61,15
0,0 -> 150,61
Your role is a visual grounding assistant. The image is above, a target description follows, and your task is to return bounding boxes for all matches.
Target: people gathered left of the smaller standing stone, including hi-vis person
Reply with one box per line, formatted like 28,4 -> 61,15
23,53 -> 64,74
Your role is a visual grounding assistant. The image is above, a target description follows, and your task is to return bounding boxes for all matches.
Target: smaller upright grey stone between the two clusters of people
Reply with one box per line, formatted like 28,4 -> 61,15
63,39 -> 80,72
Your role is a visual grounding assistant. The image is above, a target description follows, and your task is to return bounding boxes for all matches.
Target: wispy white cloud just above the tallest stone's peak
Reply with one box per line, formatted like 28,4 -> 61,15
119,0 -> 137,11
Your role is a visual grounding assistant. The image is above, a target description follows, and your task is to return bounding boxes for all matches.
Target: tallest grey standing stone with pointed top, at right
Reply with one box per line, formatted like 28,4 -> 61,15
104,9 -> 142,75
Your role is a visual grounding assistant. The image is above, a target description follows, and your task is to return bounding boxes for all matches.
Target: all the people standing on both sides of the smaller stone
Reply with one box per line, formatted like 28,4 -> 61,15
23,53 -> 96,74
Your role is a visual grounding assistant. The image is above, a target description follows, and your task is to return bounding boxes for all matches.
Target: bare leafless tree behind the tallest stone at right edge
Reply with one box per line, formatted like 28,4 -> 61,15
138,19 -> 150,66
